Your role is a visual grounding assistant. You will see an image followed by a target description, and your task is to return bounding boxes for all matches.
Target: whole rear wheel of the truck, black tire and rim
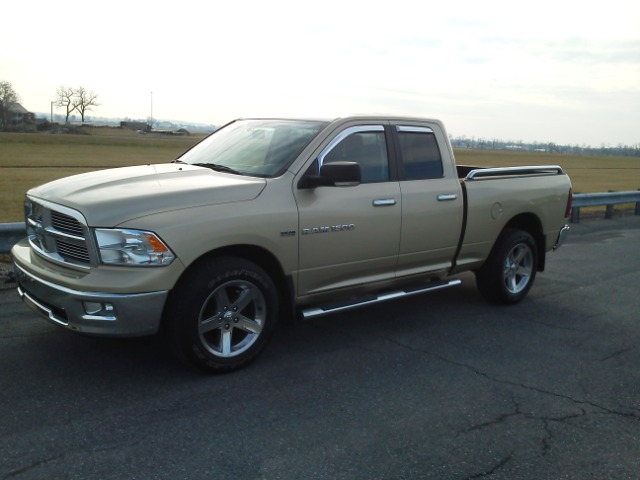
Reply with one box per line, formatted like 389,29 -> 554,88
475,228 -> 538,304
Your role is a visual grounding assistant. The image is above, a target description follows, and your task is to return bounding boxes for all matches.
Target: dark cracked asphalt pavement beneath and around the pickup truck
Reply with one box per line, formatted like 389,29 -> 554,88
0,217 -> 640,480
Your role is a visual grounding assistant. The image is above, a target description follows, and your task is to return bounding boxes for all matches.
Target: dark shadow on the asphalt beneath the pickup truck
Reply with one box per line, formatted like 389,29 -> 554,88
6,278 -> 576,392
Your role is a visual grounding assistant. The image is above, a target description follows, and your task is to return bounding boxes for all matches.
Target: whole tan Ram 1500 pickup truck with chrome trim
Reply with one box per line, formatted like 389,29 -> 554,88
12,117 -> 571,371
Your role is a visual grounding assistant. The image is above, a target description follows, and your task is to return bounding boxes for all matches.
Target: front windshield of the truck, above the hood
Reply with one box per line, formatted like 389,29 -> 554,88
177,120 -> 326,177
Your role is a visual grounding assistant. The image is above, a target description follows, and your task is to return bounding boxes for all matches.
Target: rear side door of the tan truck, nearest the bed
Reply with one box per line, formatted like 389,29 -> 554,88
392,123 -> 463,276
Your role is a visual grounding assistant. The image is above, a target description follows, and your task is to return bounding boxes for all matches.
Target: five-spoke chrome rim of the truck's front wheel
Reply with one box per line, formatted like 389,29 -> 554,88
198,280 -> 267,358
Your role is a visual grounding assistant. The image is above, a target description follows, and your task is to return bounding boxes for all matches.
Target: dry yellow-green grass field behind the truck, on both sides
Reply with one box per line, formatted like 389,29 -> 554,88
0,128 -> 640,223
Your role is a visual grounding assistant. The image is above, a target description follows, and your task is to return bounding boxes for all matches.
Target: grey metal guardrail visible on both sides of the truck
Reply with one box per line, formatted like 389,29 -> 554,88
0,190 -> 640,253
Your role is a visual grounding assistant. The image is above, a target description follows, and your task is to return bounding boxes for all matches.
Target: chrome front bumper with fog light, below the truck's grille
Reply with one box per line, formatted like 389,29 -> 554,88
13,263 -> 168,337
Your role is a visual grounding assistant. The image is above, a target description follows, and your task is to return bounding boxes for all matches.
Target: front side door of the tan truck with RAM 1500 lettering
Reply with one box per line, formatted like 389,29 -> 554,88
294,123 -> 402,295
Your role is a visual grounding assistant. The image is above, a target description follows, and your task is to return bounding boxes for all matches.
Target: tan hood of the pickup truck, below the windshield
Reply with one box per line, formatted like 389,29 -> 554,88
28,163 -> 266,227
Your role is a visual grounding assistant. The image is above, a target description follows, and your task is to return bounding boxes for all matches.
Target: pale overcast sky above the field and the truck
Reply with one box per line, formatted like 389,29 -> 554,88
0,0 -> 640,146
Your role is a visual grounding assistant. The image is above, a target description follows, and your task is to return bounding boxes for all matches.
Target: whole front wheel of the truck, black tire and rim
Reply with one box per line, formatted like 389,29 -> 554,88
165,257 -> 278,372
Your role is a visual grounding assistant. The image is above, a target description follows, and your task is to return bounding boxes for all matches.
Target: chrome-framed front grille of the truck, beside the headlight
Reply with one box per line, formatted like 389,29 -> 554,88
25,199 -> 92,268
